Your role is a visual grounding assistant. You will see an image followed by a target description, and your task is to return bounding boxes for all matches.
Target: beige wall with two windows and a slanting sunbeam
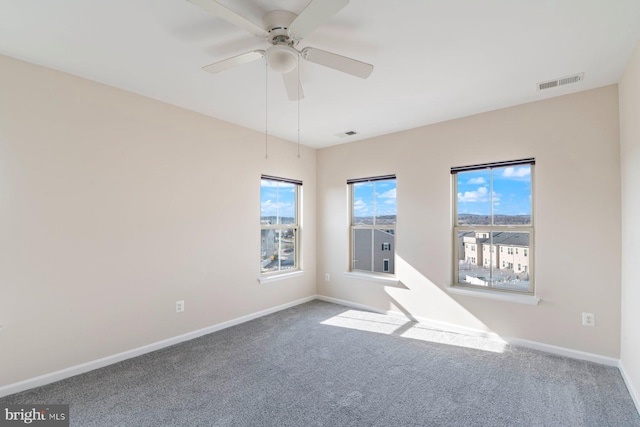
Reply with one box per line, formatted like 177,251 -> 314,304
318,85 -> 624,359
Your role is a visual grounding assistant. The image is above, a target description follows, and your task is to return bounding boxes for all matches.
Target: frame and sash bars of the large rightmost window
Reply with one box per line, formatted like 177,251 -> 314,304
451,159 -> 535,296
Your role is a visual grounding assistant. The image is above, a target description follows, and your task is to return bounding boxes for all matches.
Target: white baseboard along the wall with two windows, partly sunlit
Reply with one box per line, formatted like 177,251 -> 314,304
317,295 -> 619,367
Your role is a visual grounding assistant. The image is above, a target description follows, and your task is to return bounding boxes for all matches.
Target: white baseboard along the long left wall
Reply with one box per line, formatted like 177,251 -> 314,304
0,295 -> 316,397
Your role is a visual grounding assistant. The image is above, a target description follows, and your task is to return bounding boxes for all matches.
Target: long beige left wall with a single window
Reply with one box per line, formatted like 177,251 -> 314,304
0,56 -> 316,387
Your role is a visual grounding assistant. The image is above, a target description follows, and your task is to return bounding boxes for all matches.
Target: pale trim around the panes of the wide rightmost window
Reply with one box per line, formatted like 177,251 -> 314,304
449,158 -> 539,296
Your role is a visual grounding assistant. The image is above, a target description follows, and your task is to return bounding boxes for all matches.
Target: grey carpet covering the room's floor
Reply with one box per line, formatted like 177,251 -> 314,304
0,301 -> 640,426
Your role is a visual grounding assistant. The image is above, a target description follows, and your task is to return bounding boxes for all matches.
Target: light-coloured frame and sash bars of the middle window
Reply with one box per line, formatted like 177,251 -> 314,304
347,175 -> 398,278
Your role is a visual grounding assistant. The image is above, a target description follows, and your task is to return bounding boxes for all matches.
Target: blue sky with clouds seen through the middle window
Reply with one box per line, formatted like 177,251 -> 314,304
353,179 -> 396,217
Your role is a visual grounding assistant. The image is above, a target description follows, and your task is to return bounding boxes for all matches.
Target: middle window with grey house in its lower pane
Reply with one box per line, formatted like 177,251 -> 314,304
347,175 -> 396,274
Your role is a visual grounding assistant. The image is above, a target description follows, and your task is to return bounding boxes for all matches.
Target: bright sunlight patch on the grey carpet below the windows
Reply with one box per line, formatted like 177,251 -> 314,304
321,310 -> 506,353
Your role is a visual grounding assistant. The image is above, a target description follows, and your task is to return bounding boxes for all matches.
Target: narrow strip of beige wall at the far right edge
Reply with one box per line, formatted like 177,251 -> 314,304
619,44 -> 640,406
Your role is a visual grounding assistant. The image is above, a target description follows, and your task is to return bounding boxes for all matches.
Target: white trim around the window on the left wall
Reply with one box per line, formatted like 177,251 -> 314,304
258,175 -> 303,283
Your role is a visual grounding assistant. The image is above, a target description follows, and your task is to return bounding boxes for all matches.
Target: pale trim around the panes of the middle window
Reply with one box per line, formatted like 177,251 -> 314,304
345,174 -> 397,281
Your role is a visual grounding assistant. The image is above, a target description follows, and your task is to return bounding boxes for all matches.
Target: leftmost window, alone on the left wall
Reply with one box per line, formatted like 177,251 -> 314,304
260,175 -> 302,274
